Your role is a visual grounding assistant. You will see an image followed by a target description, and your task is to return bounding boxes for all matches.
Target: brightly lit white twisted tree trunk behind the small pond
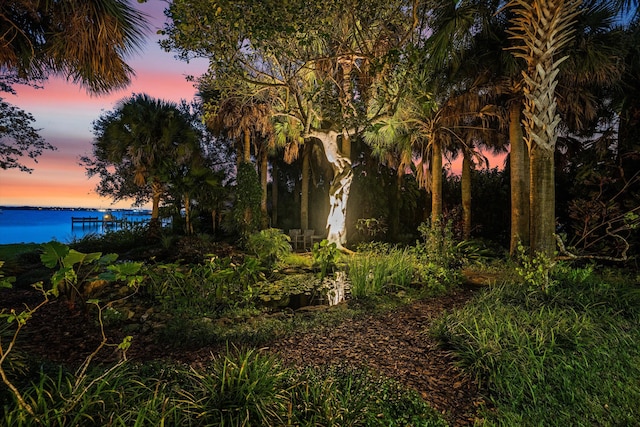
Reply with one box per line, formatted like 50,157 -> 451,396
308,130 -> 353,249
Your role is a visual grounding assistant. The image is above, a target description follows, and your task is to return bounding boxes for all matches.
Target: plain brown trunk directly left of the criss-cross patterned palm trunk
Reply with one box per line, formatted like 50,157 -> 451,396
509,102 -> 530,255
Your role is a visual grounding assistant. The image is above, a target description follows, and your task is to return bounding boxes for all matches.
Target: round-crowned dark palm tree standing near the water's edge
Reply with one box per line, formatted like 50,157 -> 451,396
93,94 -> 199,225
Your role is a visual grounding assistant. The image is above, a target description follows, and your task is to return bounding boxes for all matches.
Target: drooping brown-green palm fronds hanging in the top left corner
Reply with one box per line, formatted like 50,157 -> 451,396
0,0 -> 147,93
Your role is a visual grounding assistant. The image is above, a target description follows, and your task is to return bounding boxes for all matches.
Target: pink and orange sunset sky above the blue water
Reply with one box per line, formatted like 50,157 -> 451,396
0,0 -> 208,209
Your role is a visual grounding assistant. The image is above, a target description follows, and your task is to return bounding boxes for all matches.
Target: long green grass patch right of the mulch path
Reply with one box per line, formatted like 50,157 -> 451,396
433,266 -> 640,426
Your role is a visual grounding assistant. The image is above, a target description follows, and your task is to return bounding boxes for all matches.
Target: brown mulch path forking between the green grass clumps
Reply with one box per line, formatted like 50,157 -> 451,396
270,290 -> 483,426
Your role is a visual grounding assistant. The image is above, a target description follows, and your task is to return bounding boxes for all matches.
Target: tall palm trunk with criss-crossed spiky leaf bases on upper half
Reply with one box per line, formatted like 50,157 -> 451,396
510,0 -> 580,256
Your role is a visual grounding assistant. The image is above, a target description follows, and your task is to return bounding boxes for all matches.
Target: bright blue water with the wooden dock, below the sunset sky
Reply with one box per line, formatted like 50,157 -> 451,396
0,207 -> 149,244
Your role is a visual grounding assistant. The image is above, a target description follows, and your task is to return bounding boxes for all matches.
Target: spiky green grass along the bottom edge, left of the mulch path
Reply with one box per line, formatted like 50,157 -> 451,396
0,349 -> 446,427
